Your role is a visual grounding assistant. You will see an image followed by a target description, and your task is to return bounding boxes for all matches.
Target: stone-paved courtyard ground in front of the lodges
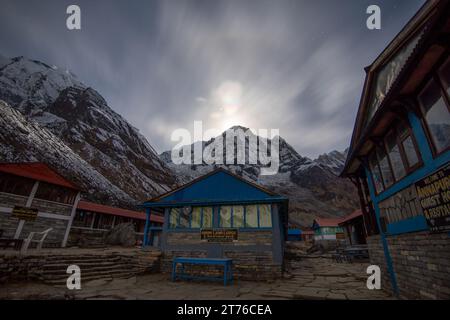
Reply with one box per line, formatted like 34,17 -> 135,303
0,257 -> 392,300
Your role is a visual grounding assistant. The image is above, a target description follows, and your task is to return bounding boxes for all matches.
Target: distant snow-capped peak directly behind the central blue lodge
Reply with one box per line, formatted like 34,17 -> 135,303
160,126 -> 359,226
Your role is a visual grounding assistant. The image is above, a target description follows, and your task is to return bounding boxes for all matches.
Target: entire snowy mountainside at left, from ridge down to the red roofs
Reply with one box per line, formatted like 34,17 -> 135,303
0,57 -> 177,206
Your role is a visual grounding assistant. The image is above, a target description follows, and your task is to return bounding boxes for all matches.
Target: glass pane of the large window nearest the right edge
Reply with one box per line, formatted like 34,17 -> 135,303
419,80 -> 450,152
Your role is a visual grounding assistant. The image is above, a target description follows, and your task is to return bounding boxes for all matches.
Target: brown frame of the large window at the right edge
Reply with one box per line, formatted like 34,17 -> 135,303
414,56 -> 450,159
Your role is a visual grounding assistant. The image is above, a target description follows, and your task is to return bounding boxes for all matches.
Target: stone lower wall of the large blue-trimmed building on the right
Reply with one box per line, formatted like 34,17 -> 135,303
368,231 -> 450,299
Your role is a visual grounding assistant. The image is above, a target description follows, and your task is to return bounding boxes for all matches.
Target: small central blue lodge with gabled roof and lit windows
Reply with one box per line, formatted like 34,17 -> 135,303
143,169 -> 288,280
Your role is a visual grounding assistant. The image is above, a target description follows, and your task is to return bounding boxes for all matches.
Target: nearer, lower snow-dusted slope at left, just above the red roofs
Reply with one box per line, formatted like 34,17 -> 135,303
0,101 -> 136,204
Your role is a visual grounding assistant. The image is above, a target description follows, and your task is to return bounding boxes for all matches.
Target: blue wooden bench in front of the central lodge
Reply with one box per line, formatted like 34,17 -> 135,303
172,257 -> 233,286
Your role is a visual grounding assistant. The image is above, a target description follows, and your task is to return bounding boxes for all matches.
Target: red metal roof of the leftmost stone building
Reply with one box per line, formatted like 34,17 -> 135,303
0,162 -> 80,190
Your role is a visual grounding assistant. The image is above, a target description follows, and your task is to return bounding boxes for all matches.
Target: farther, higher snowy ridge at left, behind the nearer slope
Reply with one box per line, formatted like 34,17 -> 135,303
0,57 -> 177,202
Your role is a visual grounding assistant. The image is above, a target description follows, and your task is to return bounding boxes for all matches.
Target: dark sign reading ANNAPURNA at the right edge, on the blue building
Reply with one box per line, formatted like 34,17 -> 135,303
416,165 -> 450,232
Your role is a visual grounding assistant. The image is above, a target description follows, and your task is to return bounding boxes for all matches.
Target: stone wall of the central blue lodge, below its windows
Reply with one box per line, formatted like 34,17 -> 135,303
161,230 -> 283,280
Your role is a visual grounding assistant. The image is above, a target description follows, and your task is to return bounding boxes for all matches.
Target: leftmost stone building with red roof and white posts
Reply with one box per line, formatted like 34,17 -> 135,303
0,162 -> 80,247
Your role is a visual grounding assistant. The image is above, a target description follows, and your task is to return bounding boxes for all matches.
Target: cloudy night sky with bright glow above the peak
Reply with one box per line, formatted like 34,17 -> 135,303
0,0 -> 424,157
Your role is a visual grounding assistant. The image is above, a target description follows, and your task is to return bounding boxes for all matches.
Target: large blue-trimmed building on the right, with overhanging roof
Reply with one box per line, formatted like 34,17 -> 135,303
342,0 -> 450,299
